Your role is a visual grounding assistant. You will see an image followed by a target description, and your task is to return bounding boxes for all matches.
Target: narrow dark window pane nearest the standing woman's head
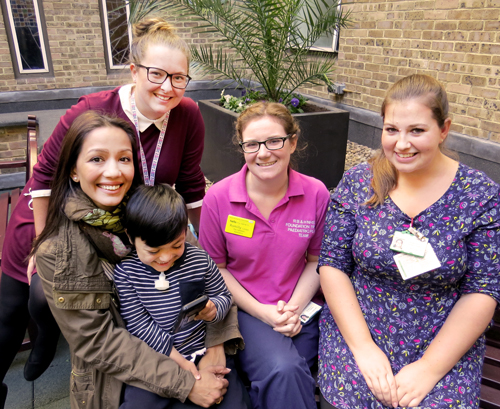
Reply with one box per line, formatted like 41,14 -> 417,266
106,0 -> 129,67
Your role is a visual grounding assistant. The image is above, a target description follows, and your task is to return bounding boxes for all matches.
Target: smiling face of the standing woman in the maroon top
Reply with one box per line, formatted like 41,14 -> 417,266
130,45 -> 188,119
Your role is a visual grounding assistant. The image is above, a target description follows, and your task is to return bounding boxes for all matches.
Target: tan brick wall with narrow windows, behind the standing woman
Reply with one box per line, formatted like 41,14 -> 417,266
0,0 -> 211,92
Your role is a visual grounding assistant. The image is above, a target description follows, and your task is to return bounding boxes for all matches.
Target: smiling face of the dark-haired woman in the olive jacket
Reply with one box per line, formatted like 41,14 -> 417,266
71,127 -> 134,211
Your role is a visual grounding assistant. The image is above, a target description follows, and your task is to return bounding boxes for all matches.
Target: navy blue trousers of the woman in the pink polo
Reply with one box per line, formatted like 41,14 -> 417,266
238,311 -> 319,409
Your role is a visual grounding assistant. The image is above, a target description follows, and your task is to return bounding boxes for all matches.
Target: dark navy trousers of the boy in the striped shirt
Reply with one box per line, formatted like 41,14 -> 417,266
120,356 -> 252,409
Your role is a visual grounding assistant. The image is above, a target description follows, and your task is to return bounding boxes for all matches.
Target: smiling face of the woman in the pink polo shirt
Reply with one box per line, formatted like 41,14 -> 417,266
242,116 -> 297,181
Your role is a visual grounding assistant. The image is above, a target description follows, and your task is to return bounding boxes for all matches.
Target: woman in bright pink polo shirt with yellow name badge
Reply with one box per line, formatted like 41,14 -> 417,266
200,102 -> 329,409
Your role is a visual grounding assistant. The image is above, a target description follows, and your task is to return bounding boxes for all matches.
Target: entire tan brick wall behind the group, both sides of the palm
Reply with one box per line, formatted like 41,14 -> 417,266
0,0 -> 500,146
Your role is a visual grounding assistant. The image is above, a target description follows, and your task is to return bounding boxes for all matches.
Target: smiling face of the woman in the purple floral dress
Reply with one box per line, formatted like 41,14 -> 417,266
382,99 -> 451,177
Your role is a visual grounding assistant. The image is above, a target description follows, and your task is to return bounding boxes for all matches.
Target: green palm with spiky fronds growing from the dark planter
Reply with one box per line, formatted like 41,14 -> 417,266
127,0 -> 349,107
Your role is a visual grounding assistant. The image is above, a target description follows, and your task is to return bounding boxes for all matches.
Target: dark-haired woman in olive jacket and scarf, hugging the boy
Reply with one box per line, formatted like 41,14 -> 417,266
33,111 -> 246,409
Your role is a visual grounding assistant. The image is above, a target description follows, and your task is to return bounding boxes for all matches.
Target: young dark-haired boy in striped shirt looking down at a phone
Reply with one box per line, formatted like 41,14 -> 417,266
115,185 -> 231,409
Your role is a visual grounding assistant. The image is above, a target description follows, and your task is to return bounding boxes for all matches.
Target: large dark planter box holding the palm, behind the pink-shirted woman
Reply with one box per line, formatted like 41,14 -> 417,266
198,100 -> 349,188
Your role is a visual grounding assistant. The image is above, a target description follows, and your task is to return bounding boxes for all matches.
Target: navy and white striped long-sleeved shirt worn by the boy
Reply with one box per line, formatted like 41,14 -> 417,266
114,243 -> 231,359
